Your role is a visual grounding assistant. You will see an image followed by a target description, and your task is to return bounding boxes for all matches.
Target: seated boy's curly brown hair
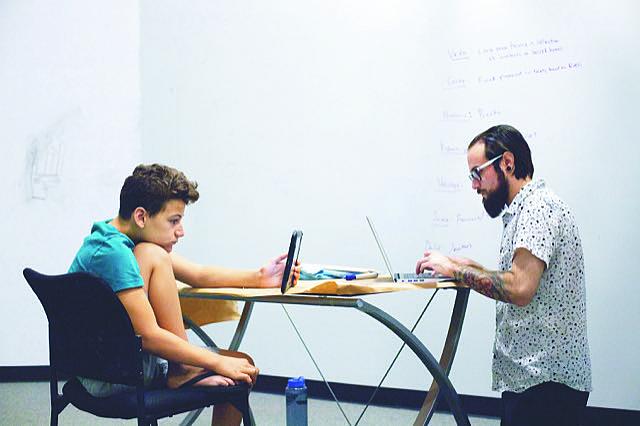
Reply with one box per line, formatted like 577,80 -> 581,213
118,164 -> 200,220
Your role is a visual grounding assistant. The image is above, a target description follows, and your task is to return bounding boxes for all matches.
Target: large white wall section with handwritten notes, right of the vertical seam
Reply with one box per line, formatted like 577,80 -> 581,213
141,0 -> 640,409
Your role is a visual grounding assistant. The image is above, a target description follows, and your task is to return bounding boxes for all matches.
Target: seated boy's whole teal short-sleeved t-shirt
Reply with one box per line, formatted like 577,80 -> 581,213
69,220 -> 144,292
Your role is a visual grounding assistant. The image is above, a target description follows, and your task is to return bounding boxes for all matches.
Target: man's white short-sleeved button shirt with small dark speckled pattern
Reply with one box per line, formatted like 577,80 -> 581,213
493,180 -> 591,392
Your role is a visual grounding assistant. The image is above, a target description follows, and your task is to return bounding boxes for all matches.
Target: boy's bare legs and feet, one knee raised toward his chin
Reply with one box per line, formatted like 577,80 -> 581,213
134,243 -> 248,425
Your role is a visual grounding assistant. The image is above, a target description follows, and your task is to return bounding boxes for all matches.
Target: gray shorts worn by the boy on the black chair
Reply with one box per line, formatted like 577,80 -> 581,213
78,352 -> 169,398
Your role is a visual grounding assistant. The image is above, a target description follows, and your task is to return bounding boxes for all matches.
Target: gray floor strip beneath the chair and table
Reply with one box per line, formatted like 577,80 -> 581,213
0,382 -> 500,426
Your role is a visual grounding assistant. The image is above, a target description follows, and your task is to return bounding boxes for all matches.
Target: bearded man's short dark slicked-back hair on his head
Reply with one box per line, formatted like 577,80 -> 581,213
468,124 -> 533,179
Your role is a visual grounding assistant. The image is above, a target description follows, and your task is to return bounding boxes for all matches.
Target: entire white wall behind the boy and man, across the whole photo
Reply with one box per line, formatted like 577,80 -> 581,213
0,0 -> 640,410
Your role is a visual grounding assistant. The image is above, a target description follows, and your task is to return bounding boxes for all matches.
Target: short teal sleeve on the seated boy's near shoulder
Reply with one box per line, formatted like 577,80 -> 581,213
89,244 -> 144,292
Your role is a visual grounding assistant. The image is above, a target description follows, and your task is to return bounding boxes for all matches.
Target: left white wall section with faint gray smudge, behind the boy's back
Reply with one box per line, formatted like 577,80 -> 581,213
0,0 -> 141,366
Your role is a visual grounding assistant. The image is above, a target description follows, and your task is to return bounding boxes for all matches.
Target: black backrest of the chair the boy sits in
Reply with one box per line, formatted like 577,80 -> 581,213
23,268 -> 142,386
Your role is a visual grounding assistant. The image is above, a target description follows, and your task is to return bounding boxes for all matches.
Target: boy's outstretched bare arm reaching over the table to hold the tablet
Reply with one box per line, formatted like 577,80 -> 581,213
171,253 -> 300,288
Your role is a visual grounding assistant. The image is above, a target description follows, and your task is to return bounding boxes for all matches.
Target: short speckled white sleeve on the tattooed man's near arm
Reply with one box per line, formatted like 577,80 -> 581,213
513,199 -> 560,267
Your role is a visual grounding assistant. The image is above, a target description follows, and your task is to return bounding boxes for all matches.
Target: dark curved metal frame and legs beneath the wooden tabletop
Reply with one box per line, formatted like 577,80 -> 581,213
180,287 -> 470,426
